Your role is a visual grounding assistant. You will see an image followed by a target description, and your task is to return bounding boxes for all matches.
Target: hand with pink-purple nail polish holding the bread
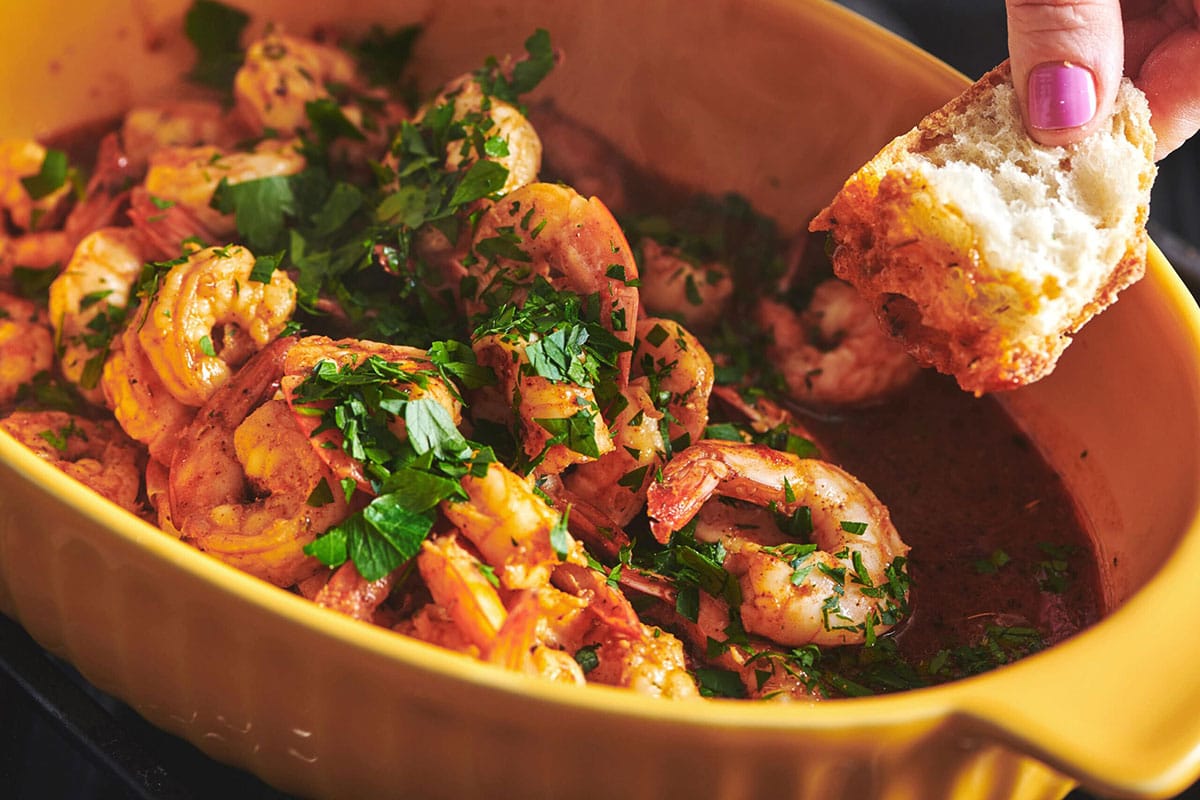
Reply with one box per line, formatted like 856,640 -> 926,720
1007,0 -> 1200,158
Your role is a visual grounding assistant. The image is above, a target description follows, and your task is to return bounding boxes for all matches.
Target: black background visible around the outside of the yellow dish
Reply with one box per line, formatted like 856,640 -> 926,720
0,0 -> 1200,800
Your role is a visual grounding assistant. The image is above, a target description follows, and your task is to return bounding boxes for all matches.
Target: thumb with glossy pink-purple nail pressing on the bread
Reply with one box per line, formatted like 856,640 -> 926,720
1007,0 -> 1124,145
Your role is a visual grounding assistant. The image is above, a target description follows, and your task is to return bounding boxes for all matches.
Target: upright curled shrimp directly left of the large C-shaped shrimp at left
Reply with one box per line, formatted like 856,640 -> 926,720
48,228 -> 144,403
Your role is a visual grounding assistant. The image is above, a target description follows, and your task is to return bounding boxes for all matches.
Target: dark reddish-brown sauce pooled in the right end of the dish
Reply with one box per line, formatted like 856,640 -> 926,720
806,371 -> 1104,661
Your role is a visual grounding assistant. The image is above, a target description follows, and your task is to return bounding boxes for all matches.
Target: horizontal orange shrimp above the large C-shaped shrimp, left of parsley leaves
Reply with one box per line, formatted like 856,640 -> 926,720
143,139 -> 306,241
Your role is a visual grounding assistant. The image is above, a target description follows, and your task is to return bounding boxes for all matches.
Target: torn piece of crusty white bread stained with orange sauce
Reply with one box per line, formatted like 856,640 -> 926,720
809,62 -> 1156,395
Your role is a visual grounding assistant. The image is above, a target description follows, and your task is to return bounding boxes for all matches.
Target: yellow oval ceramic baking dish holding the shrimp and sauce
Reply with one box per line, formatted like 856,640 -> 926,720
0,0 -> 1200,800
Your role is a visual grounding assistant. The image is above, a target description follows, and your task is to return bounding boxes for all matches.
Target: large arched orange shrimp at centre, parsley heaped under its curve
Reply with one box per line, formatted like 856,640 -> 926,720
463,184 -> 637,386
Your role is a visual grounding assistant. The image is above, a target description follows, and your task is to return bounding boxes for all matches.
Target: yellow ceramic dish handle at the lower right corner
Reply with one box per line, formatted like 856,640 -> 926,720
955,546 -> 1200,798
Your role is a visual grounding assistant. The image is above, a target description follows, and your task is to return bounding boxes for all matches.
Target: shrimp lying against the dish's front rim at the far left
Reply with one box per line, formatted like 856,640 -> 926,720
0,411 -> 145,513
